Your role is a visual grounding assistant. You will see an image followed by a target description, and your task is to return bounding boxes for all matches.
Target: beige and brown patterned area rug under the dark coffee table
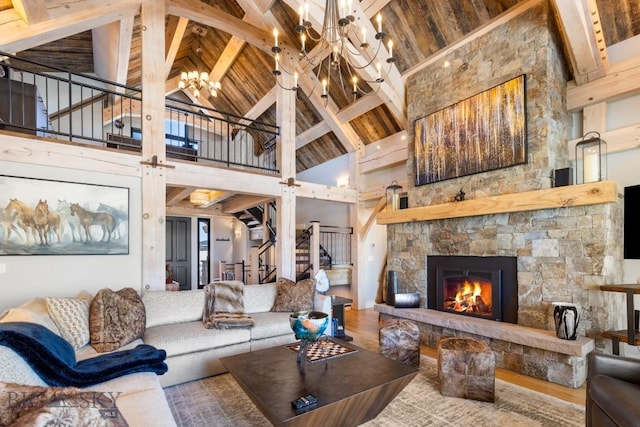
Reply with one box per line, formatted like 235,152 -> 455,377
164,355 -> 584,427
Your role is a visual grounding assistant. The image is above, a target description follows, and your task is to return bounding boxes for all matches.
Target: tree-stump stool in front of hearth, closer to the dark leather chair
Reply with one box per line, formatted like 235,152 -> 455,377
438,337 -> 496,402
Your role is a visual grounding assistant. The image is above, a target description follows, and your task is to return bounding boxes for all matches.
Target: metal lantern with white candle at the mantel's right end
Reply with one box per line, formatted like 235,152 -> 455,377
576,132 -> 607,184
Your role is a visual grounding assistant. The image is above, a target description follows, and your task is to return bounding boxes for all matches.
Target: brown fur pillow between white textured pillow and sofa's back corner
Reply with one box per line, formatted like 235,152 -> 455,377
89,288 -> 147,353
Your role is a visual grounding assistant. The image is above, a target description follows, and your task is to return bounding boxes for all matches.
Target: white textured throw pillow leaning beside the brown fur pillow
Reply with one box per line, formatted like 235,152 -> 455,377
46,297 -> 90,350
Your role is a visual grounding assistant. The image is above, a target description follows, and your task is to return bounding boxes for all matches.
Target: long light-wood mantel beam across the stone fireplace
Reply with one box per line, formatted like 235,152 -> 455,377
376,181 -> 618,225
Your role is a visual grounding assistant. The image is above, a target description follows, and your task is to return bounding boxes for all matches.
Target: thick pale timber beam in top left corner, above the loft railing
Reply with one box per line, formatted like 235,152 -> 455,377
0,0 -> 140,53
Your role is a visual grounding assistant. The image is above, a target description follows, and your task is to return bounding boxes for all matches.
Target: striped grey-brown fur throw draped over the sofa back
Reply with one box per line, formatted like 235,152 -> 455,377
202,280 -> 255,329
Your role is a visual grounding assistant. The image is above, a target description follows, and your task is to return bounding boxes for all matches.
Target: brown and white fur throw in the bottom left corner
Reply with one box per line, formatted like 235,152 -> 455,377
0,383 -> 128,427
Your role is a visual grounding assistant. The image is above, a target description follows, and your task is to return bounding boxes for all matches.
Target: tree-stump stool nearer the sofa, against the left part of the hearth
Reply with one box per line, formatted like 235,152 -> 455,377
379,319 -> 420,368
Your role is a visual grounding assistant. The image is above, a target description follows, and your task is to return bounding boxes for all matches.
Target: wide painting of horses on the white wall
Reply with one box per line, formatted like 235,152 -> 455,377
0,175 -> 130,255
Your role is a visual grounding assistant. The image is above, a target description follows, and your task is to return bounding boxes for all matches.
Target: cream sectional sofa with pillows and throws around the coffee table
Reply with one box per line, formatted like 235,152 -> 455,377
0,283 -> 331,426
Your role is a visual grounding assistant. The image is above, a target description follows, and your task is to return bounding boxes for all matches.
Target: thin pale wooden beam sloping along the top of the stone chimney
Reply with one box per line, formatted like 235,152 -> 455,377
402,0 -> 545,82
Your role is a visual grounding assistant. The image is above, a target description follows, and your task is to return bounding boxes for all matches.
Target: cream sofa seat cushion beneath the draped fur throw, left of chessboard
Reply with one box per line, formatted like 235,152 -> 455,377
144,319 -> 251,358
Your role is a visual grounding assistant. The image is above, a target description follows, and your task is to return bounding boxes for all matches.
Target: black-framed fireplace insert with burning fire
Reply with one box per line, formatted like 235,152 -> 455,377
427,256 -> 518,324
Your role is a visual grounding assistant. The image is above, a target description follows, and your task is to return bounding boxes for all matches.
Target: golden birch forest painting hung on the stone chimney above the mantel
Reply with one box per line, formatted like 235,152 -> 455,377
414,74 -> 528,186
